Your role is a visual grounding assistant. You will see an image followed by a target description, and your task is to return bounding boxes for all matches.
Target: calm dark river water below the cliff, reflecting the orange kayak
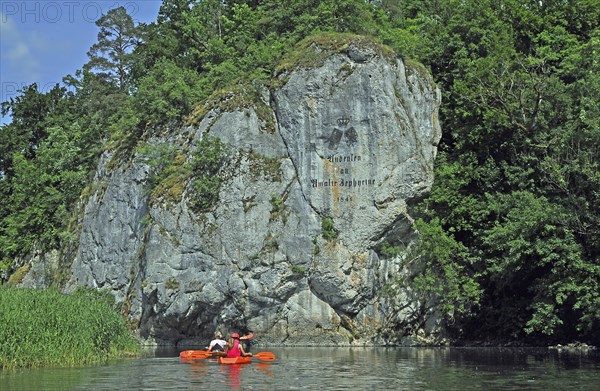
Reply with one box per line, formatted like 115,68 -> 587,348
0,347 -> 600,391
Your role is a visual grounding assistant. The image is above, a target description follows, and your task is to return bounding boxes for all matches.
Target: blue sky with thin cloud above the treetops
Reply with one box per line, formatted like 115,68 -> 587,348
0,0 -> 162,124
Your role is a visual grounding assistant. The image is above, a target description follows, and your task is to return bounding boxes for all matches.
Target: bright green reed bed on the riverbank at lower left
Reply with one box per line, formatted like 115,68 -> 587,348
0,286 -> 140,369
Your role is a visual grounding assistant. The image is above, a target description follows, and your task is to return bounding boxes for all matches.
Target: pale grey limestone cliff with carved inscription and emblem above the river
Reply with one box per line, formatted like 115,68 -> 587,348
63,39 -> 441,345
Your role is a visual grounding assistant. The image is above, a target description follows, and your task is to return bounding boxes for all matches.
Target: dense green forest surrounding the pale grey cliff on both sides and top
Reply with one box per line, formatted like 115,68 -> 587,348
0,0 -> 600,343
